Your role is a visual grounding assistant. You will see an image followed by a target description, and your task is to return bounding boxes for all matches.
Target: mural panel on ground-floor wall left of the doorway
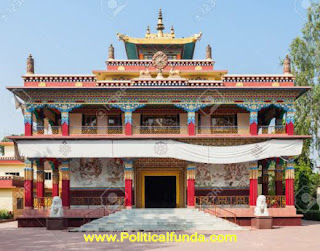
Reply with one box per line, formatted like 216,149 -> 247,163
70,158 -> 124,188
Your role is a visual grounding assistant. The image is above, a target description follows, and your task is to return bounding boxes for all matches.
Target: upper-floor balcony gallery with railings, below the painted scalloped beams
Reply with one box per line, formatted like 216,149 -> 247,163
26,105 -> 293,137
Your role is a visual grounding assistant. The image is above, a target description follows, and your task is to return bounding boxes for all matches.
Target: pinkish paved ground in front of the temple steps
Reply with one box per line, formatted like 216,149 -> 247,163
0,221 -> 320,251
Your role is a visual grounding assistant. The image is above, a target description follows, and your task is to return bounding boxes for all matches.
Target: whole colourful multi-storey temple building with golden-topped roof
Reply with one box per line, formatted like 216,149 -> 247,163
7,11 -> 310,226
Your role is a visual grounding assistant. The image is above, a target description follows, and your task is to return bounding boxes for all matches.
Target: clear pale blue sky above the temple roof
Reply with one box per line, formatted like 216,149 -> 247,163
0,0 -> 315,137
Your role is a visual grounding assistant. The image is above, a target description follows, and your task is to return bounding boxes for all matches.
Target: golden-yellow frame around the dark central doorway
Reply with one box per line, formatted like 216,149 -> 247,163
136,168 -> 184,208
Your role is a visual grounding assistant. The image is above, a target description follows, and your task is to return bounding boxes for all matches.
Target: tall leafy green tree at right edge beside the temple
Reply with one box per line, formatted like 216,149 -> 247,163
290,3 -> 320,165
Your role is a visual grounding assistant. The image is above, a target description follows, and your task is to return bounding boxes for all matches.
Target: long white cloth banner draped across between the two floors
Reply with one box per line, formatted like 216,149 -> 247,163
17,139 -> 303,164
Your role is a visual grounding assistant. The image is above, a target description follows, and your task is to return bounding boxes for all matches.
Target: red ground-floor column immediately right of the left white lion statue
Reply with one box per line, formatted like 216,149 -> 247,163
60,160 -> 70,208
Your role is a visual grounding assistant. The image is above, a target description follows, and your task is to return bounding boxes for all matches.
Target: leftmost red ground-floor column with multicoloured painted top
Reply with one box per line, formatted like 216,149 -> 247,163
24,160 -> 33,209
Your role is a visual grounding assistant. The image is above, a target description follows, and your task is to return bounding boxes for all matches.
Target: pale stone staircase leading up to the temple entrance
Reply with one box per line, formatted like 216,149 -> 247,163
70,208 -> 244,232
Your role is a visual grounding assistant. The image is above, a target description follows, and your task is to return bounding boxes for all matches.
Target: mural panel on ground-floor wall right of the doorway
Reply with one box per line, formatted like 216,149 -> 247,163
195,163 -> 249,188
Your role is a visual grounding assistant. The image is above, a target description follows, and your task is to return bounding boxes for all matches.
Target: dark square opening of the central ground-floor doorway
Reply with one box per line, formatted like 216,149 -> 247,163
144,176 -> 176,208
